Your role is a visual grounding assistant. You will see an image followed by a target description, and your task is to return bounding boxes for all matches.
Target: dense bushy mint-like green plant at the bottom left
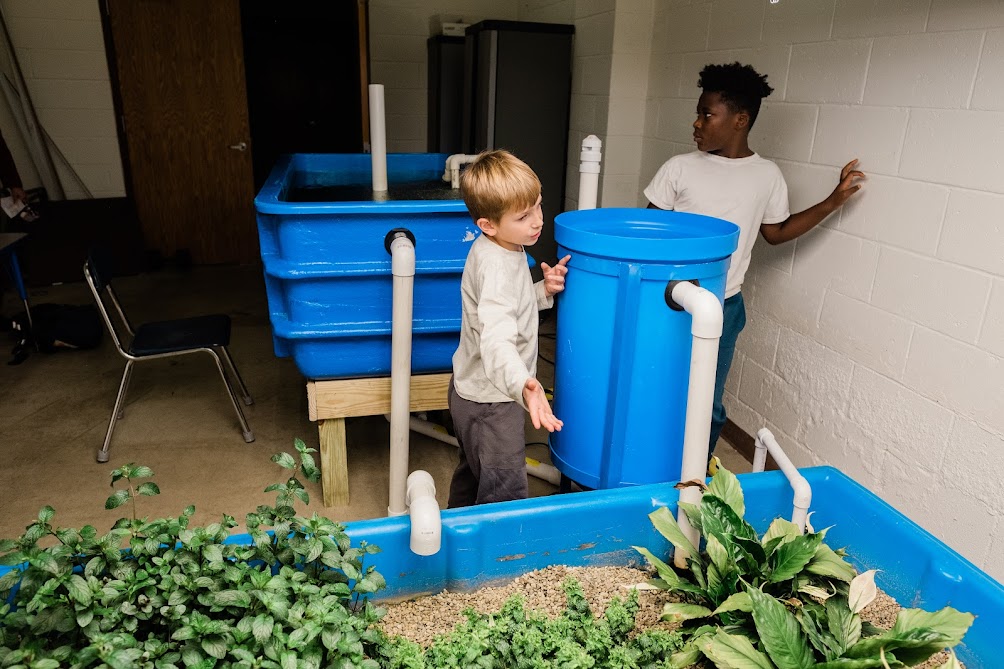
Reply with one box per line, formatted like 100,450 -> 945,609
0,439 -> 387,669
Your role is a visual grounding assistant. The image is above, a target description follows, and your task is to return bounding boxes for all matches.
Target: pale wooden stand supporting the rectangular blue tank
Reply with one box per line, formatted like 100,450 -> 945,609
307,374 -> 451,506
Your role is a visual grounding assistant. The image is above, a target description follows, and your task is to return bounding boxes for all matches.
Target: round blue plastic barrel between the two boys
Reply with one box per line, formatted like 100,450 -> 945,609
550,208 -> 739,488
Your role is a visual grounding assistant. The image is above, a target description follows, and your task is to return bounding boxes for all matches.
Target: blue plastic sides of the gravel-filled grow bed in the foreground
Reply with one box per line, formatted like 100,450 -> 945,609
348,467 -> 1004,669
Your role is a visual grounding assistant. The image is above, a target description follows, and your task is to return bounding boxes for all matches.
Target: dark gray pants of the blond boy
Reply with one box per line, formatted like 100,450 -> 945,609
447,379 -> 529,508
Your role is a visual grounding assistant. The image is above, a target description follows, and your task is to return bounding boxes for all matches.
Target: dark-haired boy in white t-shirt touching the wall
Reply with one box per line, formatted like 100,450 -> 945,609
645,62 -> 864,456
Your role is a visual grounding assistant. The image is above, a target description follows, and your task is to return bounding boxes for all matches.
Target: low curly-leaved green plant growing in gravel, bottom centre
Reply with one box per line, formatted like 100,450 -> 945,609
386,578 -> 681,669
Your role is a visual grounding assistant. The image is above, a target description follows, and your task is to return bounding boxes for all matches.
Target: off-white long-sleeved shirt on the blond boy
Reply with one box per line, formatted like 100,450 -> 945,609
453,235 -> 554,409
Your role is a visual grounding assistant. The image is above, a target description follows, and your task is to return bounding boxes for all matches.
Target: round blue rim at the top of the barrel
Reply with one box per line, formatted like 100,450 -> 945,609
554,207 -> 739,262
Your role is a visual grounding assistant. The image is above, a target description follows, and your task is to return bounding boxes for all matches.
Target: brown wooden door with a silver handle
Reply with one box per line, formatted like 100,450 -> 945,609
105,0 -> 258,264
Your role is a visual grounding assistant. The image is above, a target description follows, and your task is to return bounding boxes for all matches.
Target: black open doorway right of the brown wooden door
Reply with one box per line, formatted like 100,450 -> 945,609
240,0 -> 362,188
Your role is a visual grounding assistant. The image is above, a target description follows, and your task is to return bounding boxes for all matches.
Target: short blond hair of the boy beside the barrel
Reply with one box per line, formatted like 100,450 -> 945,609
460,150 -> 540,223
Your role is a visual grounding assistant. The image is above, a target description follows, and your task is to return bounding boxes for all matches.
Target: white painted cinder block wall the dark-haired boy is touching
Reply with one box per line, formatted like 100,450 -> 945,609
639,0 -> 1004,581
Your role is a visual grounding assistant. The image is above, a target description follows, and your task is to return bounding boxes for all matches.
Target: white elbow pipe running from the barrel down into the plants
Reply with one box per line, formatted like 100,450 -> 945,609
672,281 -> 722,568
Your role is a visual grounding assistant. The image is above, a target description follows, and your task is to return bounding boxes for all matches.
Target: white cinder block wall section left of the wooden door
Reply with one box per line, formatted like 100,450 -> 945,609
0,0 -> 126,199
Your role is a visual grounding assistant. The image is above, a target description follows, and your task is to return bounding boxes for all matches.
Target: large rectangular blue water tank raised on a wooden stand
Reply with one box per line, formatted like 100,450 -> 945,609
255,154 -> 480,380
